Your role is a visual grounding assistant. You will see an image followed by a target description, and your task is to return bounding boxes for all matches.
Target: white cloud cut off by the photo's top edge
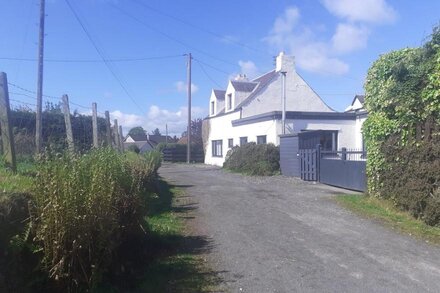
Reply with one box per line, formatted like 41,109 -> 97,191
322,0 -> 397,24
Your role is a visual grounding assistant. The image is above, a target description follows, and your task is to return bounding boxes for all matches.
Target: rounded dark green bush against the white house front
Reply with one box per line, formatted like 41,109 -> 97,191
223,142 -> 280,176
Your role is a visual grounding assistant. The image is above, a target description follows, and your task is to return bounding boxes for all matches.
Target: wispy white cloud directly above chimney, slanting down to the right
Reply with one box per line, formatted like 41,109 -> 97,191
264,7 -> 349,75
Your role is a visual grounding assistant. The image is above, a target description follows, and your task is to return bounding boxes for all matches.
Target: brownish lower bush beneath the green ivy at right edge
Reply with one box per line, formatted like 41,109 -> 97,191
381,136 -> 440,226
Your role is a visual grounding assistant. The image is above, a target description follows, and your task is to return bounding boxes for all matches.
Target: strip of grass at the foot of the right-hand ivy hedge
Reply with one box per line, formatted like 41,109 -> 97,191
336,195 -> 440,245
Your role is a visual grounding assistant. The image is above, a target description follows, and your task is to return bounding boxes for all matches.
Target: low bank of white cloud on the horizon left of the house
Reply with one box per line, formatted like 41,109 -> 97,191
110,105 -> 206,137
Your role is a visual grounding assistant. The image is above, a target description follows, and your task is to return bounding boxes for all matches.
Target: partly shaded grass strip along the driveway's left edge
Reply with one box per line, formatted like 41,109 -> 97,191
139,181 -> 220,292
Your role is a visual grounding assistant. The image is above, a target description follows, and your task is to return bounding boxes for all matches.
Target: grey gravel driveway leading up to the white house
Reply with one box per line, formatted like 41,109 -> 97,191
159,164 -> 440,292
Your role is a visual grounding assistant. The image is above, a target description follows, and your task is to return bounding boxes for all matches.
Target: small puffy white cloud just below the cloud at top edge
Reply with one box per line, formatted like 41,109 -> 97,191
331,23 -> 370,53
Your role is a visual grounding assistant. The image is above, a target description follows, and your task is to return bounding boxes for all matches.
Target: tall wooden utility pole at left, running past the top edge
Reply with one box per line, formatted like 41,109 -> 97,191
35,0 -> 46,154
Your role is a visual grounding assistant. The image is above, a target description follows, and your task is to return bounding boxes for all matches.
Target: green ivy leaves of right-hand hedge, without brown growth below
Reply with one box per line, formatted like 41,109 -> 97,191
363,26 -> 440,223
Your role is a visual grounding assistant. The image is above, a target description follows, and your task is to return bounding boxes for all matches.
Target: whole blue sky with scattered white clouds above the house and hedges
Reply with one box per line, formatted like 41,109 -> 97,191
0,0 -> 440,135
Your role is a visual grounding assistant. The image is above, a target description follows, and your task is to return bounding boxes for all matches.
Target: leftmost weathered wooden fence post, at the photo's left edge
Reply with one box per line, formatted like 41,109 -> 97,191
0,72 -> 17,173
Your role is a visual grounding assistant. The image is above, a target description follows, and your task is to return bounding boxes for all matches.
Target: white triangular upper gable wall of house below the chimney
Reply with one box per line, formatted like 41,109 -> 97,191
242,71 -> 334,118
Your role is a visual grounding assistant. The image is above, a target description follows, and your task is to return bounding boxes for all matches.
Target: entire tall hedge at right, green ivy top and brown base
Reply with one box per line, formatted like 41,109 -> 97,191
363,27 -> 440,225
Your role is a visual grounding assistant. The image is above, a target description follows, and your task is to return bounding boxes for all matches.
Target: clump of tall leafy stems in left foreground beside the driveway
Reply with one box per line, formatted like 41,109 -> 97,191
31,148 -> 160,291
